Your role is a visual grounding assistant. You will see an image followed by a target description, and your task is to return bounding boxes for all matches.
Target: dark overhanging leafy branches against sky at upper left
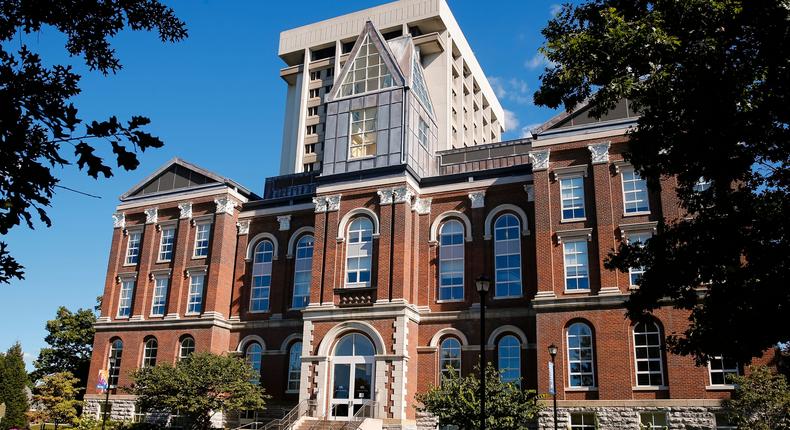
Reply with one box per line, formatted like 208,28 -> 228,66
0,0 -> 187,283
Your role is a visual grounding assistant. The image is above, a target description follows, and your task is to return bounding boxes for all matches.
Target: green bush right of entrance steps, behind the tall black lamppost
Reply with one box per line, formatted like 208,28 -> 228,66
417,365 -> 541,430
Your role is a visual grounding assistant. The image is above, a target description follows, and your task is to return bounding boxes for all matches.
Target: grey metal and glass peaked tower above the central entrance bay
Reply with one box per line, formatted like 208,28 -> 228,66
321,21 -> 437,177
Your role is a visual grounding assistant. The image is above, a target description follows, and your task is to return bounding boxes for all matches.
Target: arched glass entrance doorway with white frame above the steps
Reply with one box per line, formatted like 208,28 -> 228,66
329,333 -> 376,420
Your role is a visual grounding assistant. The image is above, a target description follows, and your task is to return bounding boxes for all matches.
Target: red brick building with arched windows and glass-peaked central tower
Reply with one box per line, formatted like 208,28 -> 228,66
86,5 -> 768,430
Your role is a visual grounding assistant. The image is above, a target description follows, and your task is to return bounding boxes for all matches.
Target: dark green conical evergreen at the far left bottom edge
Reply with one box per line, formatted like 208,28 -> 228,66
0,343 -> 30,430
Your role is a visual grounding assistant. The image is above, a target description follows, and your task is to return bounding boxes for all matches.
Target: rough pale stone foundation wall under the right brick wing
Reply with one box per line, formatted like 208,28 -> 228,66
538,406 -> 719,430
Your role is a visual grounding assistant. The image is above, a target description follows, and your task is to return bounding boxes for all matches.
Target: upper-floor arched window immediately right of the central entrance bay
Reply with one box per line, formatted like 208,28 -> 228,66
439,219 -> 464,300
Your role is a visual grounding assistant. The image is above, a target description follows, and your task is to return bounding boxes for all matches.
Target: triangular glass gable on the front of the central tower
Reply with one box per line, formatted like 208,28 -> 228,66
327,21 -> 405,101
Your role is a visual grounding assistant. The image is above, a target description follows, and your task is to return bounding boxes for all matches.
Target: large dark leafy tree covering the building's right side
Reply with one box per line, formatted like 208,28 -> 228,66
535,0 -> 790,363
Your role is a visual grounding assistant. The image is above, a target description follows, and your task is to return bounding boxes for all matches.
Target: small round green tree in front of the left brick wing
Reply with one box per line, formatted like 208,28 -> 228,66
128,353 -> 268,429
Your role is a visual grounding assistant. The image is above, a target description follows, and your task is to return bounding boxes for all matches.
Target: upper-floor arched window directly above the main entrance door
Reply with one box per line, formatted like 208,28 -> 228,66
346,217 -> 373,288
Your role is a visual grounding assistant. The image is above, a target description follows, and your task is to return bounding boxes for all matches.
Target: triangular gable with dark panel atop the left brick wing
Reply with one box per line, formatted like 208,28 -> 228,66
121,158 -> 250,200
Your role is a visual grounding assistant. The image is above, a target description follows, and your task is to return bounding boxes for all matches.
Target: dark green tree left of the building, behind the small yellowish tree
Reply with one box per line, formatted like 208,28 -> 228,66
31,306 -> 96,388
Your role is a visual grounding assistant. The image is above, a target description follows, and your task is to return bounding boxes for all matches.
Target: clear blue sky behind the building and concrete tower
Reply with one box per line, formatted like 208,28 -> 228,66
0,0 -> 559,368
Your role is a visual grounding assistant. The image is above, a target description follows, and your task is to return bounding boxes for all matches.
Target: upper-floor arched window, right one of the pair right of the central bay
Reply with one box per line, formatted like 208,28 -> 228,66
494,214 -> 521,297
